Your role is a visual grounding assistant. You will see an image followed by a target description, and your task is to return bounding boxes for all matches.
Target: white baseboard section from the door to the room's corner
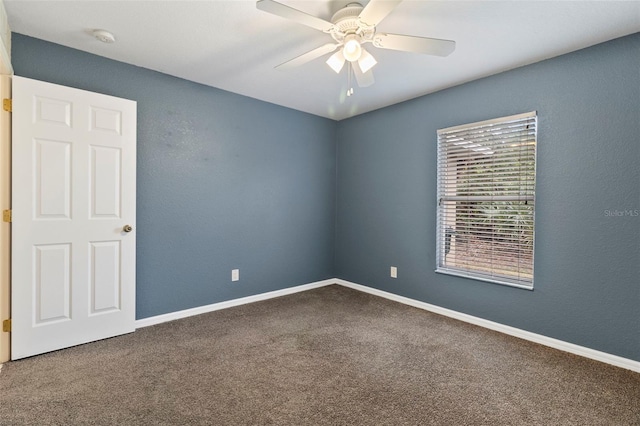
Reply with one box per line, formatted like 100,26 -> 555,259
136,279 -> 336,328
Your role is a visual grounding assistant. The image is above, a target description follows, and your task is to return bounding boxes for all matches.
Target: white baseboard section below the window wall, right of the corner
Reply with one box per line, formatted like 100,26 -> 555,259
335,279 -> 640,373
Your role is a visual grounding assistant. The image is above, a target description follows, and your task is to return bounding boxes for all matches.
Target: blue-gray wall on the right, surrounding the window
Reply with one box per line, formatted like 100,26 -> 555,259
335,34 -> 640,361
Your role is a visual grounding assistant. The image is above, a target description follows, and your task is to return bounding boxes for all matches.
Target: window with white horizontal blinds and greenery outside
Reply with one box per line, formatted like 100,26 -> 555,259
436,112 -> 537,289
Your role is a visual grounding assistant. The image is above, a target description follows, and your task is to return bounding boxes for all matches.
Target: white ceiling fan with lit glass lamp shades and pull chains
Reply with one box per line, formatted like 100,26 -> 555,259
256,0 -> 456,89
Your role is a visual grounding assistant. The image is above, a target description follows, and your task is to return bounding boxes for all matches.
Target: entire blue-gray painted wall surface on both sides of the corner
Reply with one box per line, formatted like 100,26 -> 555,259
12,34 -> 640,361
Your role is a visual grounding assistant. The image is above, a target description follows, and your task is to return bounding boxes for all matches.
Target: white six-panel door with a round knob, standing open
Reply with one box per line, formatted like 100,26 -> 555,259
11,77 -> 136,359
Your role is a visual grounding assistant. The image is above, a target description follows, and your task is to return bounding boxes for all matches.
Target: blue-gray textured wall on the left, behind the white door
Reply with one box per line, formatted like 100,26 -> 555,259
13,34 -> 336,318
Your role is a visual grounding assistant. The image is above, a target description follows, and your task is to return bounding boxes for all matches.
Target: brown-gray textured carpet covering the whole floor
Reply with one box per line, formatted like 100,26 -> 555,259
0,286 -> 640,425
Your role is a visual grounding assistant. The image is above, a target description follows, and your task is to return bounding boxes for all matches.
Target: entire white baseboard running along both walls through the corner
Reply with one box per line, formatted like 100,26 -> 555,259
136,278 -> 640,373
